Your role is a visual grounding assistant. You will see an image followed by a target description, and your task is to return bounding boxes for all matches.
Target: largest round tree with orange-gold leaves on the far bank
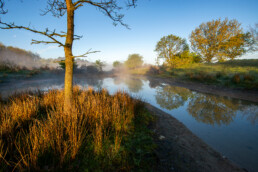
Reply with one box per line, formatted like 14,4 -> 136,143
190,18 -> 247,63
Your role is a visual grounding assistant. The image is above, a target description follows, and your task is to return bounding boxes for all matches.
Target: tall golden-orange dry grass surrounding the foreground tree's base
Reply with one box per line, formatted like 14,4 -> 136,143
0,87 -> 143,170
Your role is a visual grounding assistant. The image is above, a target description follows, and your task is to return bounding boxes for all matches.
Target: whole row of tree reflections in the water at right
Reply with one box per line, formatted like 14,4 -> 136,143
155,85 -> 250,125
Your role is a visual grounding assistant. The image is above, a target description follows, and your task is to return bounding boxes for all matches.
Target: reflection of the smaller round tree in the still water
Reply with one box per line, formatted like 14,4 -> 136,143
155,85 -> 192,110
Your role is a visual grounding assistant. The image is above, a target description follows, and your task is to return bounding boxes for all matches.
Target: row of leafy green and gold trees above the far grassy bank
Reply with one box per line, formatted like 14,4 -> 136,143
155,18 -> 258,67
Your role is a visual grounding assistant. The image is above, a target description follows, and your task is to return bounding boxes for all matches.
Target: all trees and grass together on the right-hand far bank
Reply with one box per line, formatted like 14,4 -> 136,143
113,18 -> 258,90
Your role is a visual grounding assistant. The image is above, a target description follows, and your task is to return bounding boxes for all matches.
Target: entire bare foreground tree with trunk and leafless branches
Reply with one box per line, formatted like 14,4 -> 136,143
0,0 -> 137,112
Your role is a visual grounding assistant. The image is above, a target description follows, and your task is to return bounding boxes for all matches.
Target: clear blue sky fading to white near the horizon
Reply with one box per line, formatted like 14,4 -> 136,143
0,0 -> 258,64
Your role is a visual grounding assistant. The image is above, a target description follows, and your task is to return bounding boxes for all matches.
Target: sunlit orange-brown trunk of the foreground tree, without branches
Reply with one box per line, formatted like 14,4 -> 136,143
64,0 -> 74,113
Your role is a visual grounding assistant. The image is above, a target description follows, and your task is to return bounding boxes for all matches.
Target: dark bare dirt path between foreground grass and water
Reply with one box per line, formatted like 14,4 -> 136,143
146,104 -> 245,172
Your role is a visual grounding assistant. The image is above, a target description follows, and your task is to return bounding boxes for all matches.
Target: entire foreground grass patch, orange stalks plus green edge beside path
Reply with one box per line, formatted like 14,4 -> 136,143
0,87 -> 155,171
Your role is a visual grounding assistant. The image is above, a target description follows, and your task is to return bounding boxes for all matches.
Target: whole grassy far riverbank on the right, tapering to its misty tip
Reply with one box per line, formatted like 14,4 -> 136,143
125,59 -> 258,91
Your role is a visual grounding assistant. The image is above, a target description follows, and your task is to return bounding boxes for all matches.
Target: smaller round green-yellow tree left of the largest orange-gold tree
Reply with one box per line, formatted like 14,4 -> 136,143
155,35 -> 191,68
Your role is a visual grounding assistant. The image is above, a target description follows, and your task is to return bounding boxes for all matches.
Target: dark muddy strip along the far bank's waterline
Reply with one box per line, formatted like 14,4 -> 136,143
147,76 -> 258,103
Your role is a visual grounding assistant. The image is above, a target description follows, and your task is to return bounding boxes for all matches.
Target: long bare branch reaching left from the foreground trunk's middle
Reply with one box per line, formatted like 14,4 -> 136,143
0,21 -> 66,47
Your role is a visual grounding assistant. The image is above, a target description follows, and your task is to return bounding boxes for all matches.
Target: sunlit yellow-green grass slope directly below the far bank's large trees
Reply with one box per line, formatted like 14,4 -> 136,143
150,59 -> 258,90
